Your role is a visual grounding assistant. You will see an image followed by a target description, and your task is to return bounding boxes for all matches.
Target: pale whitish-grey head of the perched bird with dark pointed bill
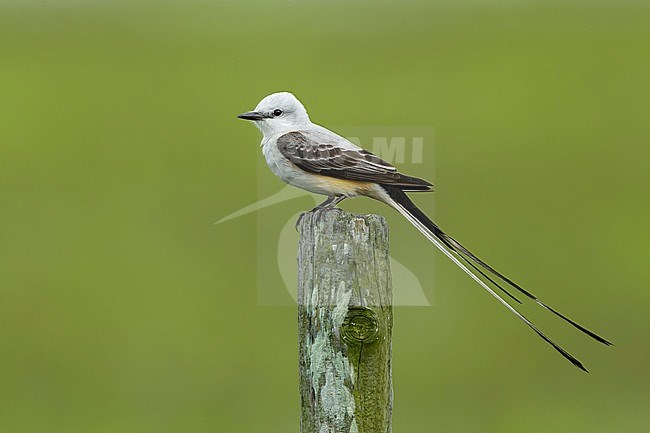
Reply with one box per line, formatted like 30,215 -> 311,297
237,92 -> 311,136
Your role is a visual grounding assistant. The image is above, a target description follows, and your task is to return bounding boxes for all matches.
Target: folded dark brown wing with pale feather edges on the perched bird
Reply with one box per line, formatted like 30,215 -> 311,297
277,131 -> 432,191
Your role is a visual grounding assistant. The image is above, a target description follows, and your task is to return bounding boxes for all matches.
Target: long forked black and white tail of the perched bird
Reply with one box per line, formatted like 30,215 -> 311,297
380,185 -> 612,371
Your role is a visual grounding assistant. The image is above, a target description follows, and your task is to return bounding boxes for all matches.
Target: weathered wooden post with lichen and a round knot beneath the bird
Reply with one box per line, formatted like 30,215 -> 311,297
298,209 -> 393,433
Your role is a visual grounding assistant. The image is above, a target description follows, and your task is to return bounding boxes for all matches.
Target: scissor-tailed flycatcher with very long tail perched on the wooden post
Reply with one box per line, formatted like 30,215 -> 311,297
238,92 -> 612,371
